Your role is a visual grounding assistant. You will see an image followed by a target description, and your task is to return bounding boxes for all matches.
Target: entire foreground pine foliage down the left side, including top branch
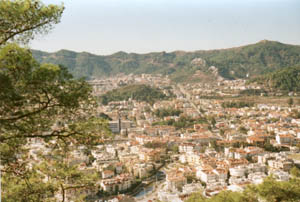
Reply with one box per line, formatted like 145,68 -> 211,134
0,0 -> 109,202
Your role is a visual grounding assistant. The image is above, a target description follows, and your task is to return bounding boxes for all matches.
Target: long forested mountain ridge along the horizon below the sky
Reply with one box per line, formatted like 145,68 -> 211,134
33,40 -> 300,81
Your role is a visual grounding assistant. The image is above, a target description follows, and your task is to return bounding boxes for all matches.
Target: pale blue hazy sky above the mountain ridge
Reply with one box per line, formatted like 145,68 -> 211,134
30,0 -> 300,55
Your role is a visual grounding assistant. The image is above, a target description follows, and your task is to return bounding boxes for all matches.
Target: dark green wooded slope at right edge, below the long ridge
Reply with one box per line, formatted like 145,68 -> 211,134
252,66 -> 300,92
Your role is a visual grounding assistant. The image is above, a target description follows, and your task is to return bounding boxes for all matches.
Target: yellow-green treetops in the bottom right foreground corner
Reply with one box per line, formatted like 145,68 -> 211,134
185,177 -> 300,202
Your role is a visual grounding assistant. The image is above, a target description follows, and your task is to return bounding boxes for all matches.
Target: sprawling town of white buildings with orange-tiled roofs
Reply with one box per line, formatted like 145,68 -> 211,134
30,74 -> 300,202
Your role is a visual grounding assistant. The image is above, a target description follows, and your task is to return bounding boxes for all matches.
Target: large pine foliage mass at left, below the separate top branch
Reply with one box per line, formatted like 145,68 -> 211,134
0,44 -> 109,201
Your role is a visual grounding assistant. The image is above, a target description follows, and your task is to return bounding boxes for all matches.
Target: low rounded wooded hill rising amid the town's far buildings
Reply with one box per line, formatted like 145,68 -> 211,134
100,84 -> 169,105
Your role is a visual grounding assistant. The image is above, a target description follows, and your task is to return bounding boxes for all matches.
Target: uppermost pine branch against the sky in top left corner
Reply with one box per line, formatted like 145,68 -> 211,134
0,0 -> 64,46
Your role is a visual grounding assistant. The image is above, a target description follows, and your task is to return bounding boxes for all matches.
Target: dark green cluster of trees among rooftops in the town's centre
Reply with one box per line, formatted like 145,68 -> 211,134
152,116 -> 207,130
